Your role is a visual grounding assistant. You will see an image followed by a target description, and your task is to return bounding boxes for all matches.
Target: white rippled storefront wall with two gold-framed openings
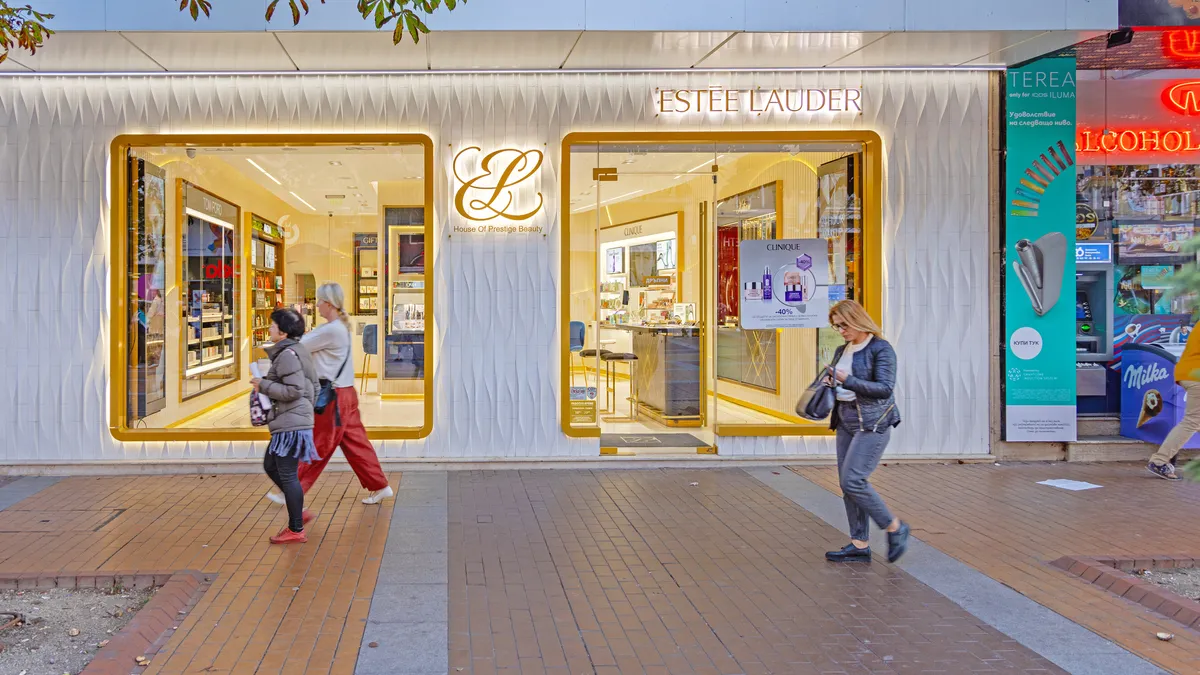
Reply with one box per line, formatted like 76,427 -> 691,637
0,70 -> 998,462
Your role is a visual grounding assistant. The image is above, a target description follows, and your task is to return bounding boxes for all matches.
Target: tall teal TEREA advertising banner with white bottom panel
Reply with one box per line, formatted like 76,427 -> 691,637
1004,58 -> 1075,441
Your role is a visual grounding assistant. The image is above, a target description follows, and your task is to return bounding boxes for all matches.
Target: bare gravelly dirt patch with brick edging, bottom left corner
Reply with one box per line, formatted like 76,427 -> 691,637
0,589 -> 154,675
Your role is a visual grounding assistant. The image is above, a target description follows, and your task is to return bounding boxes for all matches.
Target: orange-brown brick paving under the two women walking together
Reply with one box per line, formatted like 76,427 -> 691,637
0,473 -> 400,675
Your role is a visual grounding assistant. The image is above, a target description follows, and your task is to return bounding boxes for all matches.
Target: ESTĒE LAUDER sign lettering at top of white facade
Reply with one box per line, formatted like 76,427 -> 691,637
654,88 -> 863,115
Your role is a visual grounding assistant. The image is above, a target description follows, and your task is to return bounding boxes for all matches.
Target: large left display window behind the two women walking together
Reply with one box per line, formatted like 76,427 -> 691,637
110,135 -> 433,441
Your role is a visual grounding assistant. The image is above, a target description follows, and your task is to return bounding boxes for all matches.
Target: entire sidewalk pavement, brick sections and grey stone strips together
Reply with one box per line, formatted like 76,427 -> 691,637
0,465 -> 1200,675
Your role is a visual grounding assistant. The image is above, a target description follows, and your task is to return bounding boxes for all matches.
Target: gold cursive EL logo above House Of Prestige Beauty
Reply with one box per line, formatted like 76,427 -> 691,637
452,145 -> 545,222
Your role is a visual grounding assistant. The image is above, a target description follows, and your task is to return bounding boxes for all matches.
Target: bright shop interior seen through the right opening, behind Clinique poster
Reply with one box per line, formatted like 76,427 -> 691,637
568,143 -> 864,454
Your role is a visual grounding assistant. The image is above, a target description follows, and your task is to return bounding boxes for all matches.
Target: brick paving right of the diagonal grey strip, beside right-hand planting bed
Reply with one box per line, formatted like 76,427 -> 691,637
793,464 -> 1200,673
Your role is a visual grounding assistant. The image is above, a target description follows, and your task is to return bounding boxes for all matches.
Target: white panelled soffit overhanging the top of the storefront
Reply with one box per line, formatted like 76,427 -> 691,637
0,31 -> 1099,74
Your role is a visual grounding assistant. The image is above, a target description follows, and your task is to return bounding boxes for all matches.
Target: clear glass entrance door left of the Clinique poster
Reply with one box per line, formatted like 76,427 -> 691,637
571,144 -> 715,453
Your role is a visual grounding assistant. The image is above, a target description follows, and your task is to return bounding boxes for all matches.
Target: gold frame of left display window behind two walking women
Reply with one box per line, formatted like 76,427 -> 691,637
108,133 -> 436,442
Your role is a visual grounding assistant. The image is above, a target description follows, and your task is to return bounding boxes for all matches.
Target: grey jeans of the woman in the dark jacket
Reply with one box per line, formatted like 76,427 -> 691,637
838,401 -> 892,542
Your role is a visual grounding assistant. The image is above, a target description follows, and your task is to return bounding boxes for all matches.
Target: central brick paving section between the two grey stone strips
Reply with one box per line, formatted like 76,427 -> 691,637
449,470 -> 1062,675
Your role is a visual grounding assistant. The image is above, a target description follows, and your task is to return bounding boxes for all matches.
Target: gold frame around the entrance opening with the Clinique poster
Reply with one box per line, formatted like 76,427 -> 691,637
559,130 -> 883,438
